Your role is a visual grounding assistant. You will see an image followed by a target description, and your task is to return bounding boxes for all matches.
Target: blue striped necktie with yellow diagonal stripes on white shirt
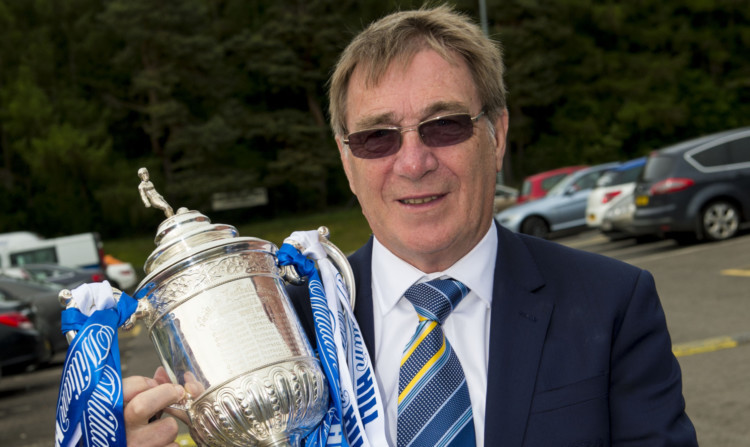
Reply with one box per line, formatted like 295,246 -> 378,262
396,279 -> 476,447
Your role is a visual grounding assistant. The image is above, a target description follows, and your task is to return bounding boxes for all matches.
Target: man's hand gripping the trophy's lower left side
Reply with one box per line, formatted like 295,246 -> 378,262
123,367 -> 186,447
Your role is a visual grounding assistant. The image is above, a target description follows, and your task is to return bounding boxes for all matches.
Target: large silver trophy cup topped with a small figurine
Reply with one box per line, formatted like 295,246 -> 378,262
61,168 -> 354,447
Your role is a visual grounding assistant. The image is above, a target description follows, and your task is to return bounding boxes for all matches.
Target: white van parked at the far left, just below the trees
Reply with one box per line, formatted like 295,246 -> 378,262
0,232 -> 104,271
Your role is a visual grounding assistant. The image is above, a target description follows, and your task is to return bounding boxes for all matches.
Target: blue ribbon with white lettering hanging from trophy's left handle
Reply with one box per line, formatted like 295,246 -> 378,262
55,286 -> 151,447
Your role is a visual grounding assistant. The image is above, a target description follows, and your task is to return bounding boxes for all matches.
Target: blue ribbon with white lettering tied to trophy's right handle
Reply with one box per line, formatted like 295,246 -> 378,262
276,244 -> 349,447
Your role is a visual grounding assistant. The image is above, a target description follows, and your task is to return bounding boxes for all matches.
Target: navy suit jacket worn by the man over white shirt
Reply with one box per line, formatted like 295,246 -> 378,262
295,224 -> 698,447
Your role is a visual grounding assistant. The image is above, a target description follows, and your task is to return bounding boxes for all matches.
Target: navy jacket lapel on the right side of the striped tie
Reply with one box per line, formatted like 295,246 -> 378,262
484,224 -> 553,445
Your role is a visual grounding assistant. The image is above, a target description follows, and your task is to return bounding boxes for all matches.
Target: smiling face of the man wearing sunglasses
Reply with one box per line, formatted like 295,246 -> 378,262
337,50 -> 507,273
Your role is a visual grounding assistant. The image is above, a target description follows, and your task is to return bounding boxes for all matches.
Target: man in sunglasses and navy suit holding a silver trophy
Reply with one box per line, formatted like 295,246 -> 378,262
125,7 -> 697,447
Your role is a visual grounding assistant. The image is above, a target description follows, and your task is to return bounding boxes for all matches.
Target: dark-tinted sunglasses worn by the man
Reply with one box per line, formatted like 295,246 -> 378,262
344,111 -> 484,158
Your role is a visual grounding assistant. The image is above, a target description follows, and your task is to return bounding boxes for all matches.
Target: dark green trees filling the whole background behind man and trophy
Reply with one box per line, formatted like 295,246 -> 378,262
0,0 -> 750,239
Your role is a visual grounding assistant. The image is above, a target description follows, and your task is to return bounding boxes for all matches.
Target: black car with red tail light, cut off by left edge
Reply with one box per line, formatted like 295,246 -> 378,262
0,293 -> 51,375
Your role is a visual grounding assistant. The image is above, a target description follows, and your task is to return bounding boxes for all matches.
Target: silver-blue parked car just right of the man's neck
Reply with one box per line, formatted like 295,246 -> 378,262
495,162 -> 620,238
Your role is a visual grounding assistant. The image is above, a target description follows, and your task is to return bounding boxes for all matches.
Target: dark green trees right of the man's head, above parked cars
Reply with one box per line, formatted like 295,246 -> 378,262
500,0 -> 750,181
